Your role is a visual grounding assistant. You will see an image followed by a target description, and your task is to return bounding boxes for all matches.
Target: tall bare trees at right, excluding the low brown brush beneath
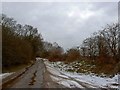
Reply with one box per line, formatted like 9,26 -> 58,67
80,23 -> 120,63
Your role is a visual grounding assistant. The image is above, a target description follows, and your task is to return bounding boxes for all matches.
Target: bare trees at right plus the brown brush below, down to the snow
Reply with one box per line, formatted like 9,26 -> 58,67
79,23 -> 120,75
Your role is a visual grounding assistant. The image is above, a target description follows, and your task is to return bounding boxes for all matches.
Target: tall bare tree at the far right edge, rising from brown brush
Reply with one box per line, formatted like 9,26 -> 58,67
101,24 -> 119,60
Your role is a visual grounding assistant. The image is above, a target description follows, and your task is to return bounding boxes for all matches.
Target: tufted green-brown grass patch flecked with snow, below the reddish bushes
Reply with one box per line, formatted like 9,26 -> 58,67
47,61 -> 95,74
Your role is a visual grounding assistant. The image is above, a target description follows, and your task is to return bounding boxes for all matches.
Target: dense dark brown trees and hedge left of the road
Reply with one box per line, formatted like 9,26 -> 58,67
0,14 -> 43,69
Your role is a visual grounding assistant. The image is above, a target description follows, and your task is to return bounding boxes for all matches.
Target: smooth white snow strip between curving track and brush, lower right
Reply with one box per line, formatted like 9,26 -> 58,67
62,73 -> 118,88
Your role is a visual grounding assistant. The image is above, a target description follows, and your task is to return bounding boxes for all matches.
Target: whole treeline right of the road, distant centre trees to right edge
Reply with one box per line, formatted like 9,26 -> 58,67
39,23 -> 120,64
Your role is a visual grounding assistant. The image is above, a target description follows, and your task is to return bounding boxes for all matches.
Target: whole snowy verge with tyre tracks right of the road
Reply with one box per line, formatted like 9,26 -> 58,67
45,60 -> 119,88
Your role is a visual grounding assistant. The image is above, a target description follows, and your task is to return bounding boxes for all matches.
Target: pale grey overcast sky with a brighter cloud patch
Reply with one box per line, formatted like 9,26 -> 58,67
2,2 -> 118,49
